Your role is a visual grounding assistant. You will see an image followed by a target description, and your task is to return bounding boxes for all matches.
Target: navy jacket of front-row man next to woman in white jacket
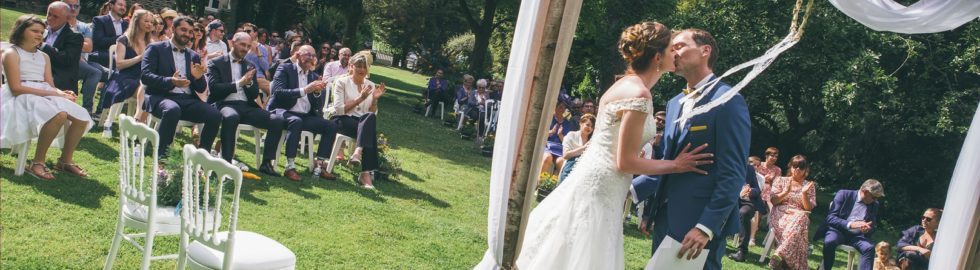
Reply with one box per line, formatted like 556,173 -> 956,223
266,60 -> 327,117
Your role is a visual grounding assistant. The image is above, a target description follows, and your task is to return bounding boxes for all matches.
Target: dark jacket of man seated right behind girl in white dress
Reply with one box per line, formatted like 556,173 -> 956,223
41,24 -> 83,92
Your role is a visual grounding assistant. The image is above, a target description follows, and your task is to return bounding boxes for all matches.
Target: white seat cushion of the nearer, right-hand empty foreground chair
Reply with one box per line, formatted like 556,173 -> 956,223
187,231 -> 296,270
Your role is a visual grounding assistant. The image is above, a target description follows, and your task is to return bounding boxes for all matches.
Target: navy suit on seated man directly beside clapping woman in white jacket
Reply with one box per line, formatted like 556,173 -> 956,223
266,59 -> 338,159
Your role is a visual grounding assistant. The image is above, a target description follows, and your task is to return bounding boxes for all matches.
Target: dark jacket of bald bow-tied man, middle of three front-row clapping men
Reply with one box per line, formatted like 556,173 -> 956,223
207,54 -> 259,108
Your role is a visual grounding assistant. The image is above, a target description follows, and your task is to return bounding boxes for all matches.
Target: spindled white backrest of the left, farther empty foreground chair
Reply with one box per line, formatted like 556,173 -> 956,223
119,115 -> 160,210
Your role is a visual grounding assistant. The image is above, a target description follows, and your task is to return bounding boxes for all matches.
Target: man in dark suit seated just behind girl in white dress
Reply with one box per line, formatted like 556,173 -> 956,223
41,1 -> 84,99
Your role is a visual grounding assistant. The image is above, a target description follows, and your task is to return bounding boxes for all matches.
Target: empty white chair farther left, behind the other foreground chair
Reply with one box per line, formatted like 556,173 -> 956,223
104,115 -> 180,269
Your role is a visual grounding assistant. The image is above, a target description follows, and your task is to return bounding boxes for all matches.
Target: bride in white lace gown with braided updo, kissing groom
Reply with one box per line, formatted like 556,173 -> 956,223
477,22 -> 712,269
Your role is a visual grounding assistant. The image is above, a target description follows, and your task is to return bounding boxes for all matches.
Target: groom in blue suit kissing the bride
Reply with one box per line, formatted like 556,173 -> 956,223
633,29 -> 751,269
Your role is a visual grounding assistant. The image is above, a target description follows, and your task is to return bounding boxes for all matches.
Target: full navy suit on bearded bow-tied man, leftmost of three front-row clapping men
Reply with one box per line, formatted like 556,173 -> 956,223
140,41 -> 221,155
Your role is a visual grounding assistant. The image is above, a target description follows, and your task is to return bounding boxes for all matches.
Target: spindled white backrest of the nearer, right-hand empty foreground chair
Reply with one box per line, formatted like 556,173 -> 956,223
180,144 -> 242,269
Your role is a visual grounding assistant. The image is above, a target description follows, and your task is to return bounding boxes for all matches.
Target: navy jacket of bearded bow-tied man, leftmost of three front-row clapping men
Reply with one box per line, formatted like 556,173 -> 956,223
140,41 -> 207,112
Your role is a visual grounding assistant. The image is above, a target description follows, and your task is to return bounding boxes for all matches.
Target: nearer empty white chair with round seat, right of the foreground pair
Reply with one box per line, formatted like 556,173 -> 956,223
177,145 -> 296,269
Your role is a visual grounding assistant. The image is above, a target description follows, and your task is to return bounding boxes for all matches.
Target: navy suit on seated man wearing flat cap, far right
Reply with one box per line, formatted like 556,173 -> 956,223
813,189 -> 878,270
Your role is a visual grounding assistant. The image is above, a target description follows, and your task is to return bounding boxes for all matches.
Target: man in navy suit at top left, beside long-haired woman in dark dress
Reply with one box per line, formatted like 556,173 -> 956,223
88,0 -> 129,67
